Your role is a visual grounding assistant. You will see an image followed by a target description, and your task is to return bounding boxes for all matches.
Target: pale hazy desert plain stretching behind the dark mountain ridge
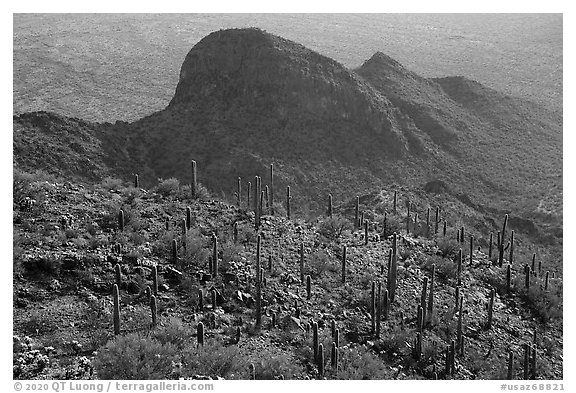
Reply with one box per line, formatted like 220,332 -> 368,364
13,14 -> 563,121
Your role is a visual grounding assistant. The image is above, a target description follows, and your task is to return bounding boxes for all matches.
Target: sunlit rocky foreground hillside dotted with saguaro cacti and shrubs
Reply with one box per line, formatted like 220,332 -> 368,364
13,171 -> 564,379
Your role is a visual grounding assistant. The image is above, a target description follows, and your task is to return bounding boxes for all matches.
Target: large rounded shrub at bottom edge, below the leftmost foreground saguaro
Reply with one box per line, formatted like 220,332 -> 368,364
94,333 -> 178,380
